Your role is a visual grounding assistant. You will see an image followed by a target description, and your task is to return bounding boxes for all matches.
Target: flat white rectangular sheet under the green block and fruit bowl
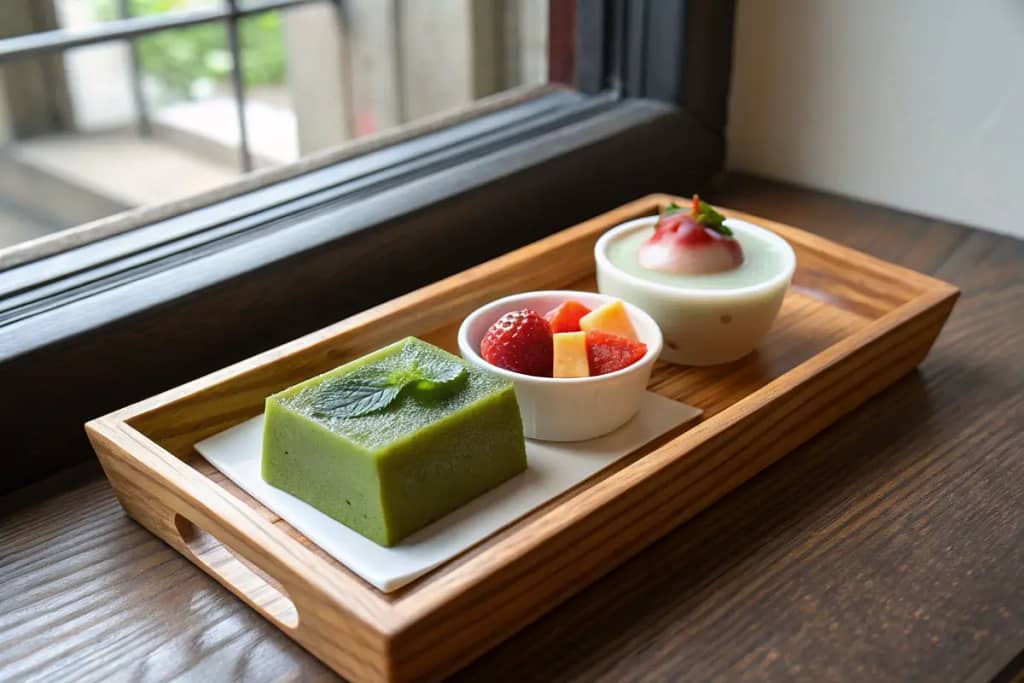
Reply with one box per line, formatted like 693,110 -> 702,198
196,391 -> 700,593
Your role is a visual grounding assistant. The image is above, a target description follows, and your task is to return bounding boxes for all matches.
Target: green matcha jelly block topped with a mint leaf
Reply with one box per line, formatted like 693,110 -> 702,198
263,337 -> 526,546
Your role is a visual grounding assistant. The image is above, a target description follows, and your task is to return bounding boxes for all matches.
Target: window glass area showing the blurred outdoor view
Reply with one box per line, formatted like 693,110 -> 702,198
0,0 -> 547,248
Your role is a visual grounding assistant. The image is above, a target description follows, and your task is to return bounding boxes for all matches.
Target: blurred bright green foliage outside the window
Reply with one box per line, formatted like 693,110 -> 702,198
89,0 -> 285,98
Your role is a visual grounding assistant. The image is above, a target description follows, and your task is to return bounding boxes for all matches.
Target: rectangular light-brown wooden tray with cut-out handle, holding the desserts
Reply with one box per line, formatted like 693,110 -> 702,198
86,195 -> 958,681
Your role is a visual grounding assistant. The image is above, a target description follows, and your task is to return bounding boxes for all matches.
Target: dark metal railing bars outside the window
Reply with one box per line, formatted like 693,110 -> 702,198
0,0 -> 340,171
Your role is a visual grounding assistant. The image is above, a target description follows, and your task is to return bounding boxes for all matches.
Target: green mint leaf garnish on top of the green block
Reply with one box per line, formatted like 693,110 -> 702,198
312,345 -> 466,418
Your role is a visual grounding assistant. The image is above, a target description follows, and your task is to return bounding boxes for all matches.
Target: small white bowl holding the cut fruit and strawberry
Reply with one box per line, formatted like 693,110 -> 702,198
459,291 -> 662,441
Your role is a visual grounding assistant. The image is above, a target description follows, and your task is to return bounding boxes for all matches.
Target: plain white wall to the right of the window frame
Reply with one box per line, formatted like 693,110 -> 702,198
728,0 -> 1024,237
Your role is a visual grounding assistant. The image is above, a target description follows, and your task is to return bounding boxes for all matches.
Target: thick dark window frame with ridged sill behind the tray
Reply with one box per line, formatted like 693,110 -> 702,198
0,0 -> 733,493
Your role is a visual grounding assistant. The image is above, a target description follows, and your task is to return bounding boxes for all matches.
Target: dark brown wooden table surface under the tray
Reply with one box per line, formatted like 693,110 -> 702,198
0,177 -> 1024,681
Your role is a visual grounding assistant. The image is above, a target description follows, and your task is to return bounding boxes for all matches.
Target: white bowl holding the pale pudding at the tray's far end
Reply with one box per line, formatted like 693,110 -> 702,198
594,216 -> 797,366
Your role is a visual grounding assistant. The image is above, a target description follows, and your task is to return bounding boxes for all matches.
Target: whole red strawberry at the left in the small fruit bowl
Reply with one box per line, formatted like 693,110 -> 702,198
480,308 -> 554,377
